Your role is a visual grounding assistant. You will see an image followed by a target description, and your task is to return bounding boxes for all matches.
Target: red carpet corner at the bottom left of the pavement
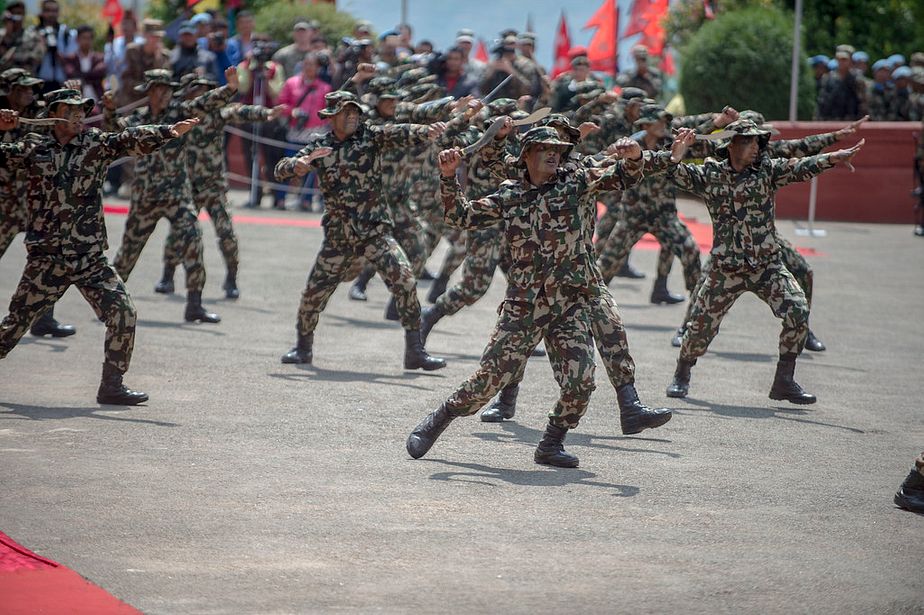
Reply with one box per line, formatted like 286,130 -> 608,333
0,532 -> 140,615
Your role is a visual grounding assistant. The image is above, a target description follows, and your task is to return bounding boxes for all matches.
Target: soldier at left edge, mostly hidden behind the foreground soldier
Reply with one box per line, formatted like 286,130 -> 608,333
0,68 -> 77,337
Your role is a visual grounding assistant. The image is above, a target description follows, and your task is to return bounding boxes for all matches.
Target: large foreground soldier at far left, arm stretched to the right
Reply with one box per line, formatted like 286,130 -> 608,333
0,98 -> 196,405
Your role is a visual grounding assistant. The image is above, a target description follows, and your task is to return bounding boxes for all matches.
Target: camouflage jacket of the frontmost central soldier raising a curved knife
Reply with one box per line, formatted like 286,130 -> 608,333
440,154 -> 642,302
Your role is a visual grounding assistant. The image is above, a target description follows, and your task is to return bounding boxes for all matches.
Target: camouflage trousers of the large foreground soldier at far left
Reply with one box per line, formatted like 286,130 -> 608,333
0,253 -> 137,374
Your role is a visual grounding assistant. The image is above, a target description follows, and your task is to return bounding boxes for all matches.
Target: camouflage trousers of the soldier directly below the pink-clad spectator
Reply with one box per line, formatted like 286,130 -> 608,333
297,235 -> 420,335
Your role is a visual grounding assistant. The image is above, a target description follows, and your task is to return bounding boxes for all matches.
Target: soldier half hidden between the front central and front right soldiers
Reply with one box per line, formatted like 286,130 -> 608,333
597,105 -> 701,303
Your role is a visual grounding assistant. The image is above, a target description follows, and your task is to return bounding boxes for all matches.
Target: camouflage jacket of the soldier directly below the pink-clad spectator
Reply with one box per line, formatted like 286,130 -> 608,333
276,122 -> 429,248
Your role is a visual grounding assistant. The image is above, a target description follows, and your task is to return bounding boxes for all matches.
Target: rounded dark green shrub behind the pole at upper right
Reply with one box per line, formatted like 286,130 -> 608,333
680,7 -> 815,120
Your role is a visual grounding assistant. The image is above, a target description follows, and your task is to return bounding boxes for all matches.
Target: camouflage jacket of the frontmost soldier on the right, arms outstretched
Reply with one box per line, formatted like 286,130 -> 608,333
650,151 -> 834,270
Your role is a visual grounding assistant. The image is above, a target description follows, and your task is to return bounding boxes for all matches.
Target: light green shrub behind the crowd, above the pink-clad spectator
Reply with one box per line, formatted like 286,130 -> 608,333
254,0 -> 356,47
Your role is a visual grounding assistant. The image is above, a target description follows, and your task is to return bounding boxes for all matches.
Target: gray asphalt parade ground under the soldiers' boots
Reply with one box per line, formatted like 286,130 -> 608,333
0,194 -> 924,614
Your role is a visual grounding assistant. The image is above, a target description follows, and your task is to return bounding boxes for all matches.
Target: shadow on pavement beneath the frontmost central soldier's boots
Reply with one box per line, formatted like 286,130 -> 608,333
426,459 -> 639,498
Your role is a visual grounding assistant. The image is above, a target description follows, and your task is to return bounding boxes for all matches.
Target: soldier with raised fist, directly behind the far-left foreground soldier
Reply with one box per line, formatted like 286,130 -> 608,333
103,66 -> 238,323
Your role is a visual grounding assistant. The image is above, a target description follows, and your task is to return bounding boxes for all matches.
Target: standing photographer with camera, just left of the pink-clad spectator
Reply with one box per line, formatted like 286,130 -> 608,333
237,34 -> 286,209
